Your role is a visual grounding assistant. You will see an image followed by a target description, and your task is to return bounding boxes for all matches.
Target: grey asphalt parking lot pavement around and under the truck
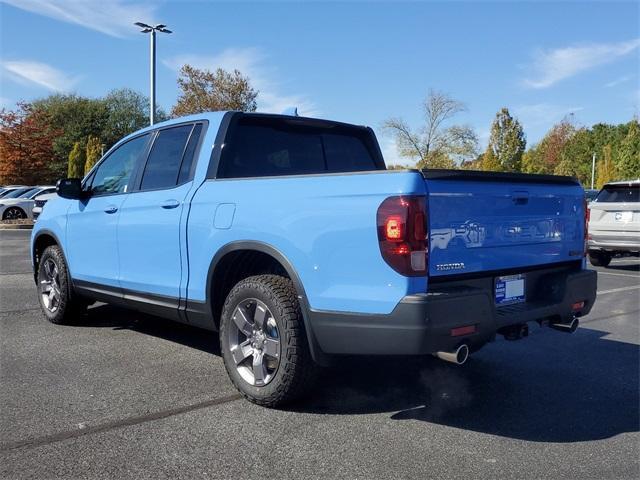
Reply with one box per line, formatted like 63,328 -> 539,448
0,230 -> 640,479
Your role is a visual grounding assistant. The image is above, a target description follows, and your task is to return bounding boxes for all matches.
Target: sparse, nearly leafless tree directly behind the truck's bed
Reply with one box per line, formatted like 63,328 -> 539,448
383,90 -> 478,168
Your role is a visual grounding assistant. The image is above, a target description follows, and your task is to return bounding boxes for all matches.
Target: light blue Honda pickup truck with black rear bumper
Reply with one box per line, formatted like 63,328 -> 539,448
31,112 -> 596,406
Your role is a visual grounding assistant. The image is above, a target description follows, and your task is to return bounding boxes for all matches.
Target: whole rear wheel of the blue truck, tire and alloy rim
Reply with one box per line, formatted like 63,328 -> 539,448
220,275 -> 316,407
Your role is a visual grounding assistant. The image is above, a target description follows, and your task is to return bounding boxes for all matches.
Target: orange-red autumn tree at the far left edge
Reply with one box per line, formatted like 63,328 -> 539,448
0,102 -> 61,185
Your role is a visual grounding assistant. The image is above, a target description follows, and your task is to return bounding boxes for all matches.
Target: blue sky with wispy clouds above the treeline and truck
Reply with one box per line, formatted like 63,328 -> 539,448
0,0 -> 640,161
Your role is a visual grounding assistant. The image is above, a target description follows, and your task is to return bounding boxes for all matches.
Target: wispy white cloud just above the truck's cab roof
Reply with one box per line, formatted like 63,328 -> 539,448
162,48 -> 319,117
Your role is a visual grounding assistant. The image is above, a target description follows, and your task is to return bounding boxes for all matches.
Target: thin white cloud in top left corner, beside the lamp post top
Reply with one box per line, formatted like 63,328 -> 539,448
1,0 -> 156,37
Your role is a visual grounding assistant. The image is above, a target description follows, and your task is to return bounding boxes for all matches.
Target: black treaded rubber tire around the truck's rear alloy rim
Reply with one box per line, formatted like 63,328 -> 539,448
220,275 -> 317,408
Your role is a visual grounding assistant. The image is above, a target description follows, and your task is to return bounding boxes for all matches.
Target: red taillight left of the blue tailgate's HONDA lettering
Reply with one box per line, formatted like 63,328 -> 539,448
377,195 -> 427,277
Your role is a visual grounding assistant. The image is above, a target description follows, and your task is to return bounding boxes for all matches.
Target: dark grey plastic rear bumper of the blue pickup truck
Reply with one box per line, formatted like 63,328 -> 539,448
310,268 -> 597,355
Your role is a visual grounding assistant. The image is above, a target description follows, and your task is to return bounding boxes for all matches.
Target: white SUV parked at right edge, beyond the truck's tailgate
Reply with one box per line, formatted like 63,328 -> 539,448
589,180 -> 640,267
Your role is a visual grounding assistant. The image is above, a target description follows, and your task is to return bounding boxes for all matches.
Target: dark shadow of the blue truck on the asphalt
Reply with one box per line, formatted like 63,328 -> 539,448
78,305 -> 640,443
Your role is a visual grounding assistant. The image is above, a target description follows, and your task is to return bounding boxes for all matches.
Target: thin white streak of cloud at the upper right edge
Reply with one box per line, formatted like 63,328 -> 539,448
524,38 -> 640,88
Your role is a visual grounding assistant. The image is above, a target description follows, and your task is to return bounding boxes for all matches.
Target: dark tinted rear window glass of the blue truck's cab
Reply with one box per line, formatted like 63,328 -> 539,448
218,117 -> 382,178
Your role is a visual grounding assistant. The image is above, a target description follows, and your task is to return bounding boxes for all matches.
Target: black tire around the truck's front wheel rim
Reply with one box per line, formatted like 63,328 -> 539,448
37,245 -> 87,325
